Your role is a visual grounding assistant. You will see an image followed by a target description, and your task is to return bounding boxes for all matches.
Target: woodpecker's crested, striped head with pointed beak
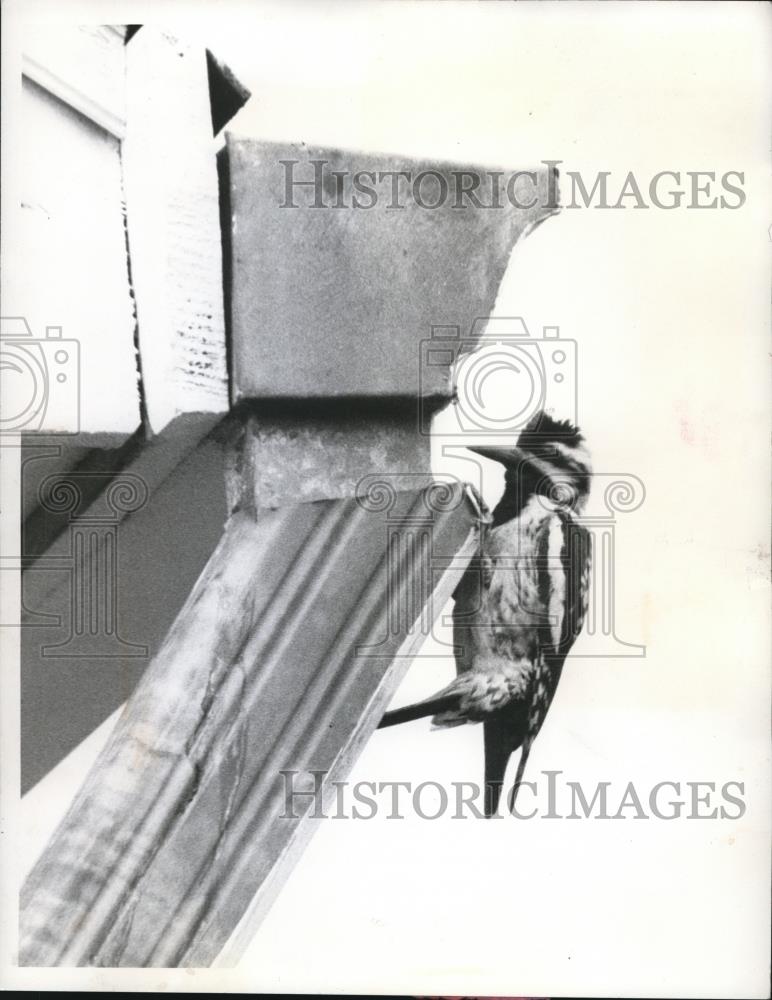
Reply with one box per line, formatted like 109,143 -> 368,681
470,410 -> 592,513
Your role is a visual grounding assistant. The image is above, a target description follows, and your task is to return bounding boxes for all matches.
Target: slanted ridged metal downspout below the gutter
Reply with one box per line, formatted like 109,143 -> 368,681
21,483 -> 476,966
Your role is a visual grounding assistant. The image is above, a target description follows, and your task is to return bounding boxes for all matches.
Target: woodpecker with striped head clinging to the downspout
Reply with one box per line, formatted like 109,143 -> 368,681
379,411 -> 592,817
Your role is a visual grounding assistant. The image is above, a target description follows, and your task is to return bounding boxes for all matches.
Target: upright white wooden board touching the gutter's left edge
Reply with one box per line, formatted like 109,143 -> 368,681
123,25 -> 229,433
